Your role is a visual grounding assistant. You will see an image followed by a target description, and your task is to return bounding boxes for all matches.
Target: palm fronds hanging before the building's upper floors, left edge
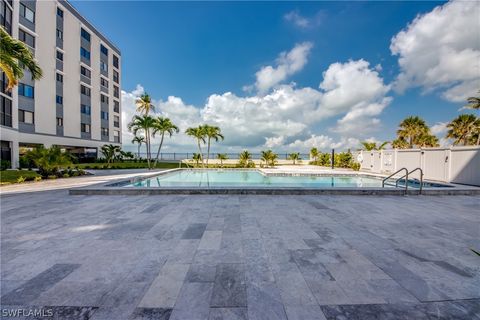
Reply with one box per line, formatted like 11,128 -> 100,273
0,27 -> 43,91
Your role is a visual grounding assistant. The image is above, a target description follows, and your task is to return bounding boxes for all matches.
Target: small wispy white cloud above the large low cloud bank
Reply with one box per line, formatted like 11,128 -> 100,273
253,42 -> 313,93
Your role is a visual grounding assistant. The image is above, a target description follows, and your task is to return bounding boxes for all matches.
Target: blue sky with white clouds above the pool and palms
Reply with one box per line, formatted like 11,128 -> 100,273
72,1 -> 480,152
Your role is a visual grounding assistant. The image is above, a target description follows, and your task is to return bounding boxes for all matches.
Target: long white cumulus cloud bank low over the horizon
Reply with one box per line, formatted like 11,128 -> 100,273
122,60 -> 391,151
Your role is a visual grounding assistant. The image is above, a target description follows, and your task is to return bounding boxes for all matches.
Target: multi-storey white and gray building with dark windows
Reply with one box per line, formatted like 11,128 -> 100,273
0,0 -> 122,168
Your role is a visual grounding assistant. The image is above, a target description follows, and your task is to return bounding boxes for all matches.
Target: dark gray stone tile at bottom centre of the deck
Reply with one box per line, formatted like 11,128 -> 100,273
210,263 -> 247,307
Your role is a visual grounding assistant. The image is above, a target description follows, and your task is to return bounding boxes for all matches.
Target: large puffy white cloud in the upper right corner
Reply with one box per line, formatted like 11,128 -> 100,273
390,0 -> 480,102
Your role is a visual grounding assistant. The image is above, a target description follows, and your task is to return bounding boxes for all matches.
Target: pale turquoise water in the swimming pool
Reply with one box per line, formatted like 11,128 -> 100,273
124,170 -> 400,188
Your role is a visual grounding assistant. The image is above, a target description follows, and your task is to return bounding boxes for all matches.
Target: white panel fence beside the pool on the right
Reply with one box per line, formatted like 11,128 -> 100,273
354,146 -> 480,186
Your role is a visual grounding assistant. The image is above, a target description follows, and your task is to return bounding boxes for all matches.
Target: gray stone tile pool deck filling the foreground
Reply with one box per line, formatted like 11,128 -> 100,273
0,190 -> 480,320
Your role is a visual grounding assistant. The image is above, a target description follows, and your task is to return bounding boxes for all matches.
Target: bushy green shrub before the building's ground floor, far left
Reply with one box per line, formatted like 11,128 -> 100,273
25,146 -> 72,177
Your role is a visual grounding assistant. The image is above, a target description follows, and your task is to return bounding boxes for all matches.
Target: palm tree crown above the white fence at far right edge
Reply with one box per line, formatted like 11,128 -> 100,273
447,114 -> 480,146
